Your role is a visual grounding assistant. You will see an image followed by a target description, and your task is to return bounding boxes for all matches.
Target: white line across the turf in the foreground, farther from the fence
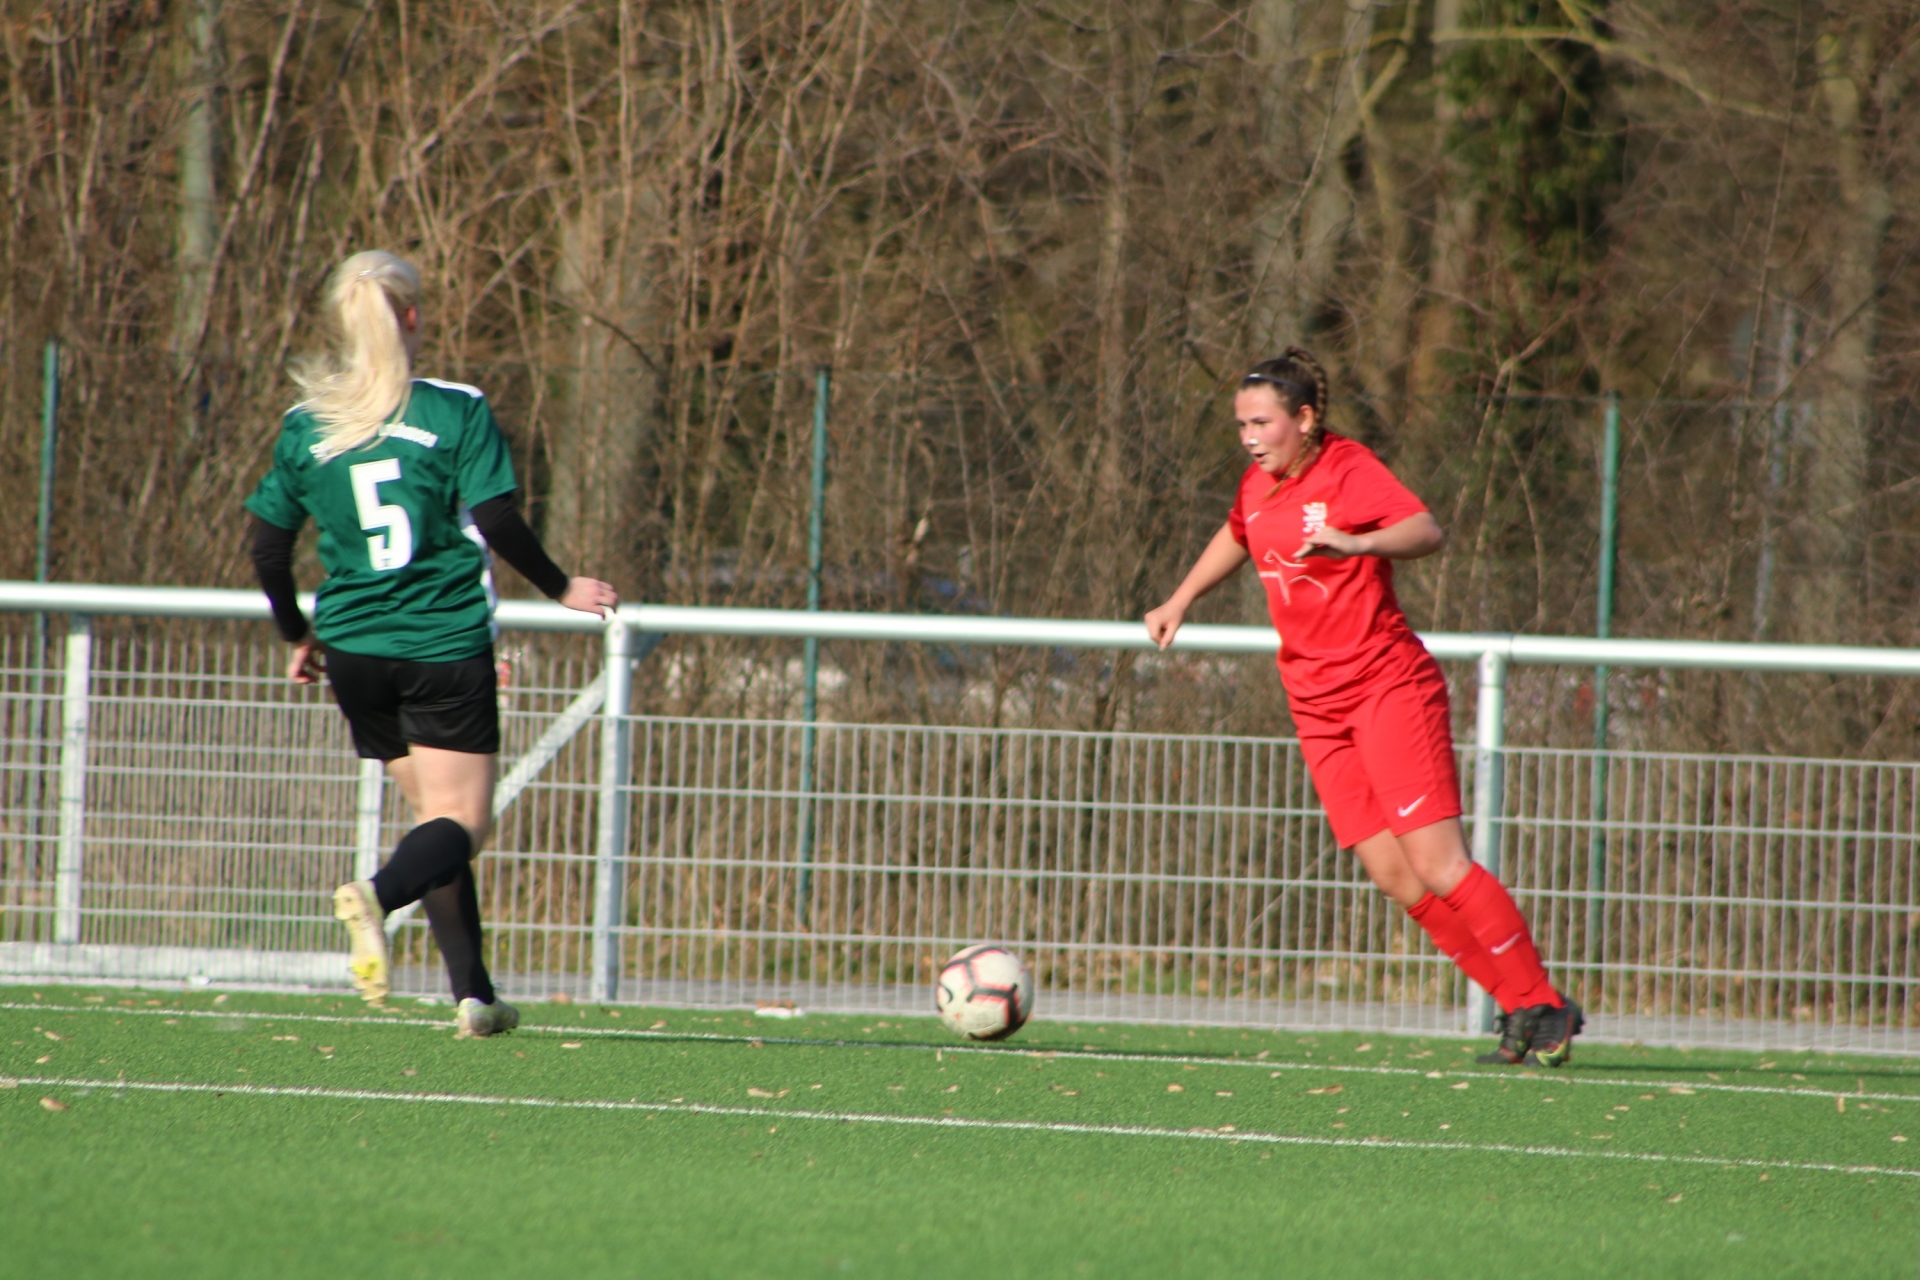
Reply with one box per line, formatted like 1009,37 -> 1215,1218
0,1077 -> 1920,1178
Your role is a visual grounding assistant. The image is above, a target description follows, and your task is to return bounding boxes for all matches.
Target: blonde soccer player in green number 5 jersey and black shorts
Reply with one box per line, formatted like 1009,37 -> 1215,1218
246,249 -> 620,1038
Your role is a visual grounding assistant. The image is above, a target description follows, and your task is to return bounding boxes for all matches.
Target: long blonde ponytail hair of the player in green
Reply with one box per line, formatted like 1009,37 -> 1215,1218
294,249 -> 420,462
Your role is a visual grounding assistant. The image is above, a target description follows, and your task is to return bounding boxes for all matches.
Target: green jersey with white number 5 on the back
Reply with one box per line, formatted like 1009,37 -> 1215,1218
246,378 -> 515,662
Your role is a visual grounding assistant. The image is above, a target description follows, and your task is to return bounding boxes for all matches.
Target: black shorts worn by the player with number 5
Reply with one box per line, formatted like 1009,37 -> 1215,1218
326,649 -> 499,760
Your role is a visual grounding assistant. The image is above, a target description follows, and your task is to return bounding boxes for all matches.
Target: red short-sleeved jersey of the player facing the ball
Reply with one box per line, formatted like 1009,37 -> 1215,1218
1227,432 -> 1427,699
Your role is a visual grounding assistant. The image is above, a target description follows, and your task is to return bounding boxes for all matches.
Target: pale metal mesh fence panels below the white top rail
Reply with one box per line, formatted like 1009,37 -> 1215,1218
0,624 -> 1920,1052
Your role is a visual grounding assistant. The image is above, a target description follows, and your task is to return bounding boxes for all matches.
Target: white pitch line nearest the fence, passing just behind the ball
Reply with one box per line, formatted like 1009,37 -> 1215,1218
15,1002 -> 1920,1102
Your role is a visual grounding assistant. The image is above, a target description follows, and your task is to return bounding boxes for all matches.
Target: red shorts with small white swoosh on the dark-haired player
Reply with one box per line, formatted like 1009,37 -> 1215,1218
1292,652 -> 1459,848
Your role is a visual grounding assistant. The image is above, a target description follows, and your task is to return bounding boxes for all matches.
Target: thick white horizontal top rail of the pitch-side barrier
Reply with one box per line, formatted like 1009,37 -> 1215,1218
0,581 -> 1920,676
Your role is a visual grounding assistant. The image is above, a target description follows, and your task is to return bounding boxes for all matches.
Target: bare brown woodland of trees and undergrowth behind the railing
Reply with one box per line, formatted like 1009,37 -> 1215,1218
0,0 -> 1920,756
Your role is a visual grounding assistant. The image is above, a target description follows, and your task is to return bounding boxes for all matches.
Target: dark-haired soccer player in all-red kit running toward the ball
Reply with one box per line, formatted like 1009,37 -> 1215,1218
1146,347 -> 1584,1067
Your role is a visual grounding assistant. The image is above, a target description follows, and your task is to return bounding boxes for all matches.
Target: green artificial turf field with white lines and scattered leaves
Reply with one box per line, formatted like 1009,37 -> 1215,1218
0,986 -> 1920,1280
